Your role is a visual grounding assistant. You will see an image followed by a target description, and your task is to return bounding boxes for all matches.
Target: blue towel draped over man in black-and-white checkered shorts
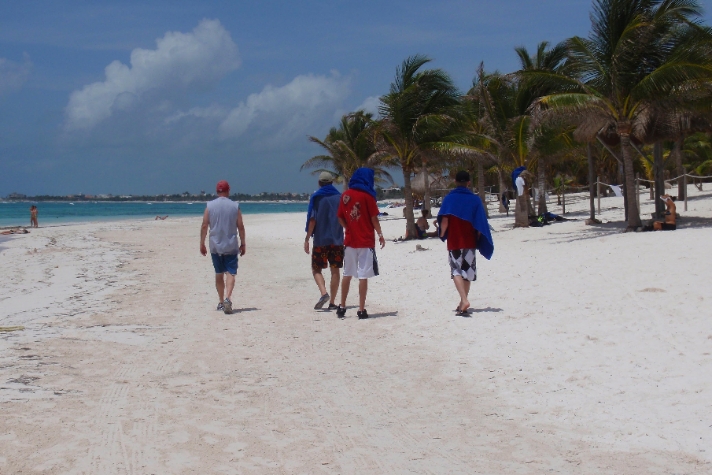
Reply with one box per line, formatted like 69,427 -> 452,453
438,186 -> 494,260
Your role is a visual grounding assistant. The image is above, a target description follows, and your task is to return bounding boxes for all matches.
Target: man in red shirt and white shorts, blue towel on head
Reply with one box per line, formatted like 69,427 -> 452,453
336,168 -> 386,319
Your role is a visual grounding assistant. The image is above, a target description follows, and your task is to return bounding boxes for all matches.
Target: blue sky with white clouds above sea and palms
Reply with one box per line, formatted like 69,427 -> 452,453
0,0 -> 712,196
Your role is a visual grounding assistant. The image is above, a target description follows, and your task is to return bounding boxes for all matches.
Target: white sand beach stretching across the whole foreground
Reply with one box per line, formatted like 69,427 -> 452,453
0,192 -> 712,474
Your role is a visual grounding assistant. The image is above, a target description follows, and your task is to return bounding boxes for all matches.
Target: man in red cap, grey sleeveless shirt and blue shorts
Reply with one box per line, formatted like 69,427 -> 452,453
200,180 -> 245,315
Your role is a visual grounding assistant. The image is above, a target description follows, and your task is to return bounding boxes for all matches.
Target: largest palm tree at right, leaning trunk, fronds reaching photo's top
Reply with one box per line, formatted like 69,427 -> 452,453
525,0 -> 712,230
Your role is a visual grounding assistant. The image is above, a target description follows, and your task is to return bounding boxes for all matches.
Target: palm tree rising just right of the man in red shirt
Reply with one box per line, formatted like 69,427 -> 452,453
377,55 -> 460,236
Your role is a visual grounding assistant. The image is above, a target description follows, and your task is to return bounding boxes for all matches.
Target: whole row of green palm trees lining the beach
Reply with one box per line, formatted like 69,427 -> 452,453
303,0 -> 712,234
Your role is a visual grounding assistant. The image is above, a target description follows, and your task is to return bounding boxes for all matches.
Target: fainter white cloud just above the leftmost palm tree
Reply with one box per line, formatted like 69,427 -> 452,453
220,72 -> 349,142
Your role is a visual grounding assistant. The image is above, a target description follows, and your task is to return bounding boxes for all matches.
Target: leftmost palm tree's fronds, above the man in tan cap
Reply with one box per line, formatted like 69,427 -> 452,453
299,111 -> 393,188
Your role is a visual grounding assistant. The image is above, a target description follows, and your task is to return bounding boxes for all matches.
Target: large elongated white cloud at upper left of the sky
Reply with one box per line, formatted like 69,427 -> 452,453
65,20 -> 240,131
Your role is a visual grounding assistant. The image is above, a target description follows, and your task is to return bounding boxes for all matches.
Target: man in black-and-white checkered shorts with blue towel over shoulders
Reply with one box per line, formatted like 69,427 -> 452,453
438,171 -> 494,316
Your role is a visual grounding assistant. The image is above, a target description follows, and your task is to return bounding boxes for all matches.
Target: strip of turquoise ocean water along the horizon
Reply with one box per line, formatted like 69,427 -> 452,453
0,201 -> 307,227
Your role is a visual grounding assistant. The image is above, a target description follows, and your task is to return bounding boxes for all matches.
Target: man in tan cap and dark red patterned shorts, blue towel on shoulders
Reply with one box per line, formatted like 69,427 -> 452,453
304,172 -> 344,310
